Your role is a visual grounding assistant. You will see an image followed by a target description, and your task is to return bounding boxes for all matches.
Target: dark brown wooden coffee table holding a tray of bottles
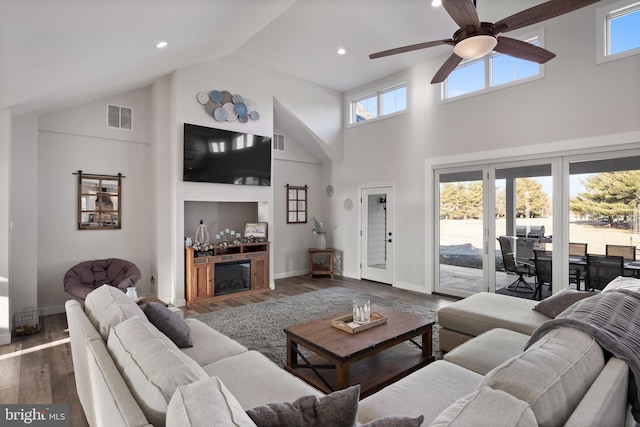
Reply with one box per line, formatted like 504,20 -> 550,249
284,305 -> 435,398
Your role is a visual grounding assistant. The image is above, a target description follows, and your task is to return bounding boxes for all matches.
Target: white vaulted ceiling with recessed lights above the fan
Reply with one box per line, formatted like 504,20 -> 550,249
0,0 -> 552,114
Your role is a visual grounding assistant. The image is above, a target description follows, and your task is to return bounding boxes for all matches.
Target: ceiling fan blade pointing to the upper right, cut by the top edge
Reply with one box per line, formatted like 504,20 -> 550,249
495,0 -> 600,34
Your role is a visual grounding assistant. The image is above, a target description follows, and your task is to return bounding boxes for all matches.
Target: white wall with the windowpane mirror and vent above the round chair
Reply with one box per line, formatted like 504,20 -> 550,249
35,88 -> 155,314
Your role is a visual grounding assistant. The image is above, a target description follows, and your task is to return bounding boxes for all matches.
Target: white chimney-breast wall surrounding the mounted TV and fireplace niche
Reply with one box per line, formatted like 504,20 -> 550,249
168,54 -> 342,303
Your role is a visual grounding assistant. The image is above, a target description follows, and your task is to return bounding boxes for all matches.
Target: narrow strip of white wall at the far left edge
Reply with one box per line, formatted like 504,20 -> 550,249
0,109 -> 11,345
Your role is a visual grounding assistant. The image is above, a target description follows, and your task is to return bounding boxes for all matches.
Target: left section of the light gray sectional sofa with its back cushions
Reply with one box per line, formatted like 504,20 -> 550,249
66,285 -> 322,427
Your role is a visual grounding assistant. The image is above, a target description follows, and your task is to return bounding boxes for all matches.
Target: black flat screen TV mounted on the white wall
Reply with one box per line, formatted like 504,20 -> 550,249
182,123 -> 271,186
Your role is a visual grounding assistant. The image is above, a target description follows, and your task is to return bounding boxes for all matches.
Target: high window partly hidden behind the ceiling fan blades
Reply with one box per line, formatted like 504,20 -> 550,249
442,31 -> 544,99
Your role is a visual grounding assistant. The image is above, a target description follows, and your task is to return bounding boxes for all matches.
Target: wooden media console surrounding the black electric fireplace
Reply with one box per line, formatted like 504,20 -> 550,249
185,242 -> 270,306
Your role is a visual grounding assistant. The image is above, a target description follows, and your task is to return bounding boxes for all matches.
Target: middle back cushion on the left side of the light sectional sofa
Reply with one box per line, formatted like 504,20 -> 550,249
107,317 -> 208,426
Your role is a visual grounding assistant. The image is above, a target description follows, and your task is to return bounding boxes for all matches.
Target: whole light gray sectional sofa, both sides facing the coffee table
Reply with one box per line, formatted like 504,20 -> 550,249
66,281 -> 640,427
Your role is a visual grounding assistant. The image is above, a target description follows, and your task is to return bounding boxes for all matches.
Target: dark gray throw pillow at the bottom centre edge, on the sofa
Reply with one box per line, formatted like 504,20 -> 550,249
247,384 -> 360,427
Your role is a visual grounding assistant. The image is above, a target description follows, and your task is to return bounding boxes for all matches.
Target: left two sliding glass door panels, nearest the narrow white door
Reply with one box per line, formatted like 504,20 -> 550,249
434,160 -> 553,296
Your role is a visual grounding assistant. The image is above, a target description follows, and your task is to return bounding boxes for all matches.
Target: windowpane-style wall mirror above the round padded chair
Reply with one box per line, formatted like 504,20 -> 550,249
78,171 -> 123,230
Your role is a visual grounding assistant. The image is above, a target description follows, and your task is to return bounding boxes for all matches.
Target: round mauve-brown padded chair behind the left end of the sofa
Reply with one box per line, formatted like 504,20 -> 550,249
64,258 -> 142,299
